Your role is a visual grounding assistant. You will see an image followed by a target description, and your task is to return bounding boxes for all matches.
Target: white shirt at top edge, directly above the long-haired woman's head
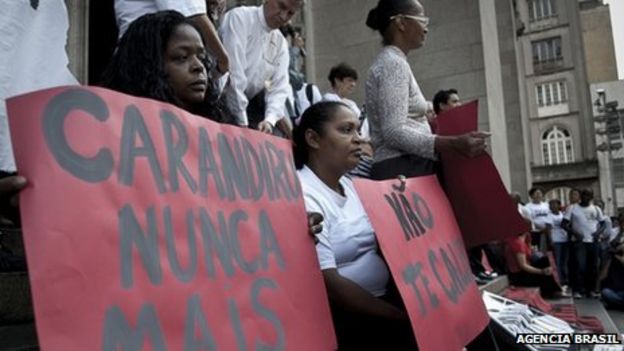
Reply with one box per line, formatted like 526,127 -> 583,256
115,0 -> 206,38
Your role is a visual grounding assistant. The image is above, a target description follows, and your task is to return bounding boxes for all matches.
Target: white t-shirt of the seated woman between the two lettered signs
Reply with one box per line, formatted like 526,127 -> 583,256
298,166 -> 390,296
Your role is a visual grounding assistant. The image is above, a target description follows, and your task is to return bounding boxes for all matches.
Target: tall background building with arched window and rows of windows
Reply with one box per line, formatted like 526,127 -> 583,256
516,0 -> 601,204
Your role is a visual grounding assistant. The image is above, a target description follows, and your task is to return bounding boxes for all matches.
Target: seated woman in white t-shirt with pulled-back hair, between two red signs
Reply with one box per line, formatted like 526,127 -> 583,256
293,101 -> 417,350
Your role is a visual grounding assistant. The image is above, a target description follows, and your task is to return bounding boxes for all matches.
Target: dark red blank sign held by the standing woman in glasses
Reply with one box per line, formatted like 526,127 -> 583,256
437,101 -> 529,247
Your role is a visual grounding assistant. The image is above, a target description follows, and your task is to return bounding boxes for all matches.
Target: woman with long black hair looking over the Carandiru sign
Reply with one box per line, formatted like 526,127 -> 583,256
101,11 -> 218,120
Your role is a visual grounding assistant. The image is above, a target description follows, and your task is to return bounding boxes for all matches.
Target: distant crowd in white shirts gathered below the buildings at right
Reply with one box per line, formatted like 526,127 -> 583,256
506,188 -> 624,308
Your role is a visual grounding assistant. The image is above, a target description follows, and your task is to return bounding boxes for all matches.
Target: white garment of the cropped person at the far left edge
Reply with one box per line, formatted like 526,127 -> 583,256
0,0 -> 78,172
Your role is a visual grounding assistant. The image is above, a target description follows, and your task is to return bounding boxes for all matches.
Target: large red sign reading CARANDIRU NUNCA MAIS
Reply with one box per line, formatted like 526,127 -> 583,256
8,88 -> 336,351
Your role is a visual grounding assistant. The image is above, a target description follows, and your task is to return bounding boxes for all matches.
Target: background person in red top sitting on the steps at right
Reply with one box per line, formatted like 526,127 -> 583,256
505,232 -> 561,298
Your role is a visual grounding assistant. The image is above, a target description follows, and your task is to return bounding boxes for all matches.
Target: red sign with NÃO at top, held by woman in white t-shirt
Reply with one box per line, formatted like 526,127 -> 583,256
355,176 -> 489,351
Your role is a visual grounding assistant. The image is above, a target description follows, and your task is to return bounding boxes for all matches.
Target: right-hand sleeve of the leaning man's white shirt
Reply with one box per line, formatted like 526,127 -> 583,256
264,36 -> 292,126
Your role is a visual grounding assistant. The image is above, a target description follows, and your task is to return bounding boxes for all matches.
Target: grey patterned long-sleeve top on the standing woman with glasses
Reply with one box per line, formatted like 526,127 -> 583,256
366,45 -> 436,162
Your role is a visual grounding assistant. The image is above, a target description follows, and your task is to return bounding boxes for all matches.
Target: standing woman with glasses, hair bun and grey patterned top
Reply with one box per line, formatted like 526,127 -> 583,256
366,0 -> 489,180
